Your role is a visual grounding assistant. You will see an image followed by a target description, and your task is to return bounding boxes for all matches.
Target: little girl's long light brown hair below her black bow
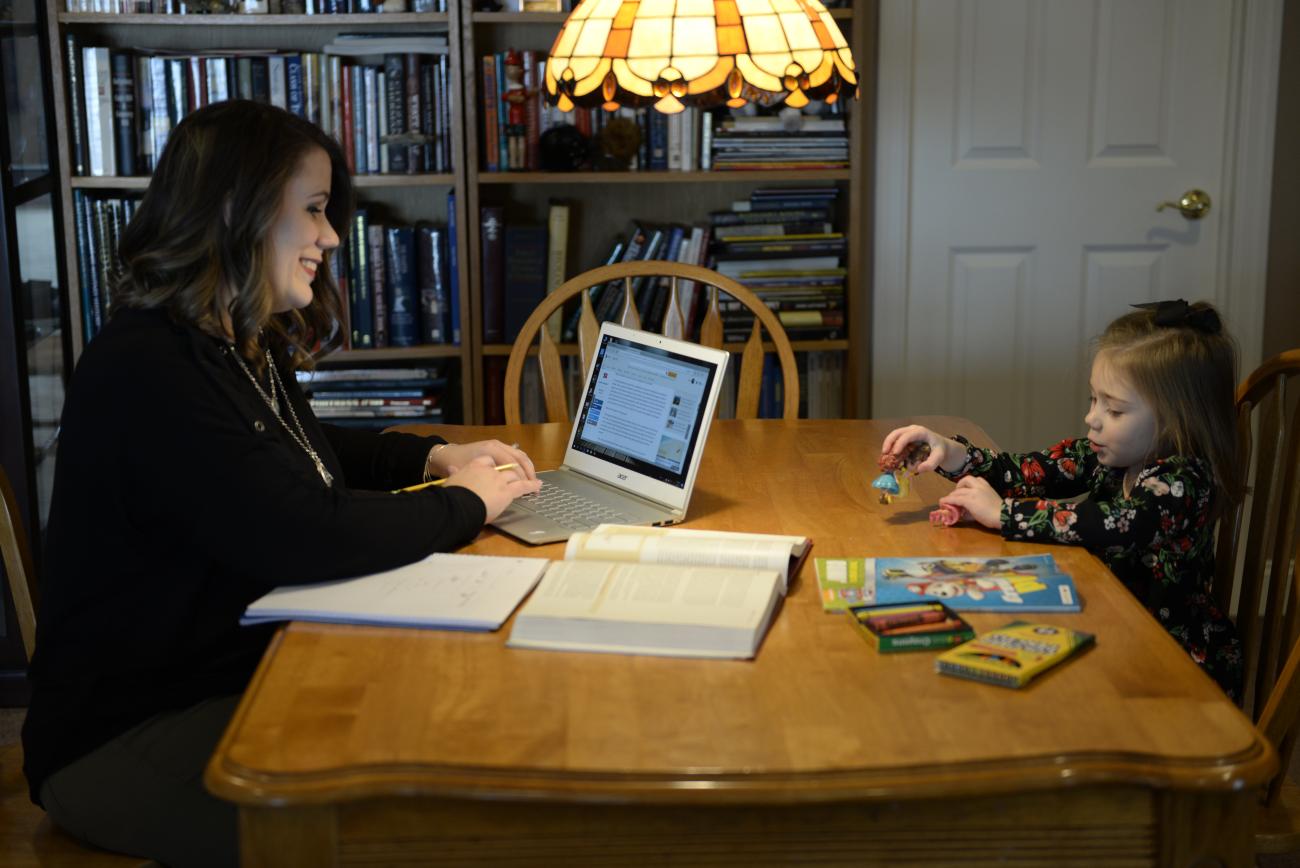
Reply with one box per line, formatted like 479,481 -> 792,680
1097,300 -> 1244,507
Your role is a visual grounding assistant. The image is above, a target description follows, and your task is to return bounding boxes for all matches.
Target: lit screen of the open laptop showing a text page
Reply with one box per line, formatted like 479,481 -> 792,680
572,334 -> 718,489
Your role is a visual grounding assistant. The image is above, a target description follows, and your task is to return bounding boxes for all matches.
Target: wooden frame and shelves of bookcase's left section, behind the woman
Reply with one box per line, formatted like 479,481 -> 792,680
46,0 -> 473,422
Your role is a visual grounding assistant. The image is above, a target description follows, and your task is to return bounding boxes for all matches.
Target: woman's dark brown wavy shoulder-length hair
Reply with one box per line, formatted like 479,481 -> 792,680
113,100 -> 352,370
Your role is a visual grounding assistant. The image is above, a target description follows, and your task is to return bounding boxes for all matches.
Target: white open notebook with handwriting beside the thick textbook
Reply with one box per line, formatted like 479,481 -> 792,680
241,554 -> 550,630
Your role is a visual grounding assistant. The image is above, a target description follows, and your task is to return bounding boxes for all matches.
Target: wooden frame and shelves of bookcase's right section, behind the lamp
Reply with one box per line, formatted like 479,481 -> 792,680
460,0 -> 875,418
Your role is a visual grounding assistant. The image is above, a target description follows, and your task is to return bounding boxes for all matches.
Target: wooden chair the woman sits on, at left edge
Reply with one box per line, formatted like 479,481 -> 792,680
0,468 -> 157,868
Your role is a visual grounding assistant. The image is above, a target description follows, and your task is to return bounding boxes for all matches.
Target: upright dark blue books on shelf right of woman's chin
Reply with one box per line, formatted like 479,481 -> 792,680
337,208 -> 460,350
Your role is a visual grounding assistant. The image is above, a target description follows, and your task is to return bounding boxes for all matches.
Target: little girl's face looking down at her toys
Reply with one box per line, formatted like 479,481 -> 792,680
1083,352 -> 1156,469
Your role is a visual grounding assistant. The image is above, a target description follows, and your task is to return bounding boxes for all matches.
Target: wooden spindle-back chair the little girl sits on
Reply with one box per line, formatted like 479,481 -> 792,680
1214,350 -> 1300,852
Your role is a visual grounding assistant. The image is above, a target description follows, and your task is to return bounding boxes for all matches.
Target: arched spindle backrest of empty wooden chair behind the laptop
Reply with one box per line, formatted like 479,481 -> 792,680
504,260 -> 800,425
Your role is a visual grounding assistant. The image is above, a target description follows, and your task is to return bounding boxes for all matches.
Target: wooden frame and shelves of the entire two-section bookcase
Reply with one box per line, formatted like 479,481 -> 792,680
46,0 -> 876,422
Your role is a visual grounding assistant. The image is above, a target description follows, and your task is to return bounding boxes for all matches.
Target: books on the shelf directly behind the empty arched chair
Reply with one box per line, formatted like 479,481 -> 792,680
480,186 -> 848,343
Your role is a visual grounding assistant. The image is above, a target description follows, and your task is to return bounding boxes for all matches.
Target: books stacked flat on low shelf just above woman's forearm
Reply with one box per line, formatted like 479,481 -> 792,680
296,368 -> 447,429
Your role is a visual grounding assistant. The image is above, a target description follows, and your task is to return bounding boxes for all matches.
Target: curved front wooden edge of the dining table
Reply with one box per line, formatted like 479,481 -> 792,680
203,628 -> 1278,807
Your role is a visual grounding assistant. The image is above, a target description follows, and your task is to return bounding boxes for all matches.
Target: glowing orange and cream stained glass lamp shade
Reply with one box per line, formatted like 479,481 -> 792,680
546,0 -> 858,114
